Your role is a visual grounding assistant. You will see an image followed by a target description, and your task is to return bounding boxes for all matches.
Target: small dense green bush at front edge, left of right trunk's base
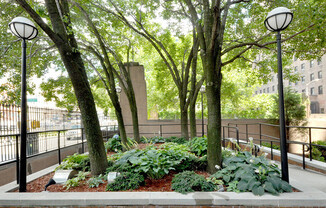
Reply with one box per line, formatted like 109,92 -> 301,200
172,171 -> 215,194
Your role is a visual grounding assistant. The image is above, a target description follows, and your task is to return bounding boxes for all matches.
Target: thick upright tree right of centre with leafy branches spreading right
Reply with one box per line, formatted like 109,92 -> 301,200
183,0 -> 326,172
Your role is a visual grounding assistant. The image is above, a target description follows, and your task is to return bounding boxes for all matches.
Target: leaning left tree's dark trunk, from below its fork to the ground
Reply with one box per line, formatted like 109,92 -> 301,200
57,45 -> 108,175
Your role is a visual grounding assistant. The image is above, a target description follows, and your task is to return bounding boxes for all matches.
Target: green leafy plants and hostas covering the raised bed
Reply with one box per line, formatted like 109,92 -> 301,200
51,137 -> 292,195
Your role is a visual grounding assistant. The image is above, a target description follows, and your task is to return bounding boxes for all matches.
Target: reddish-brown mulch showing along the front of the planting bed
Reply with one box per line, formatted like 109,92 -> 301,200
21,171 -> 209,192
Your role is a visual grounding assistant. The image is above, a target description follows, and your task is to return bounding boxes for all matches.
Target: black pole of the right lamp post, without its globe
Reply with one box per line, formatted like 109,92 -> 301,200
276,31 -> 289,182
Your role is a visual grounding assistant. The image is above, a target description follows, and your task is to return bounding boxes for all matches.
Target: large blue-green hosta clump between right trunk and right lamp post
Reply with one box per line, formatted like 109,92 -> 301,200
211,152 -> 292,195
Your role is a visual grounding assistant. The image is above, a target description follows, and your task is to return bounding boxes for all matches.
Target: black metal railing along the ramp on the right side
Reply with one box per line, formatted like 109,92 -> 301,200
227,123 -> 326,169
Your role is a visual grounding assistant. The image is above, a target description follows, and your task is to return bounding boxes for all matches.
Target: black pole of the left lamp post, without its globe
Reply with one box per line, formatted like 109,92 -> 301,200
19,39 -> 27,192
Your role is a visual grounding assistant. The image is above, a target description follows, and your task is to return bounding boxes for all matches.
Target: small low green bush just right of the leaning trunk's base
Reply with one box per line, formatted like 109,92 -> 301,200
106,172 -> 145,191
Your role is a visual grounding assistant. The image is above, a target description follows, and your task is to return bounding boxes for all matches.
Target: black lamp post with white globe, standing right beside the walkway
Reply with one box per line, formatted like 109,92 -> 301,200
264,7 -> 293,182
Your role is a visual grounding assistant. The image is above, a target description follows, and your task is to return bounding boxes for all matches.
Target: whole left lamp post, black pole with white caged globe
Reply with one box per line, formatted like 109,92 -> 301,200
9,17 -> 38,192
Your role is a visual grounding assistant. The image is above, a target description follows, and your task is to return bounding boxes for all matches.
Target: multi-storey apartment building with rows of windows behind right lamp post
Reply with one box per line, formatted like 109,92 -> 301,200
255,55 -> 326,114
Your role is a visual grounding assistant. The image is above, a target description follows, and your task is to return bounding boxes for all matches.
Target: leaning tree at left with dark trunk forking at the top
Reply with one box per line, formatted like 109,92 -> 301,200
16,0 -> 108,175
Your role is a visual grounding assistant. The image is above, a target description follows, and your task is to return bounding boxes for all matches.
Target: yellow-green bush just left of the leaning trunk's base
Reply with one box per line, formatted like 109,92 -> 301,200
55,153 -> 91,171
